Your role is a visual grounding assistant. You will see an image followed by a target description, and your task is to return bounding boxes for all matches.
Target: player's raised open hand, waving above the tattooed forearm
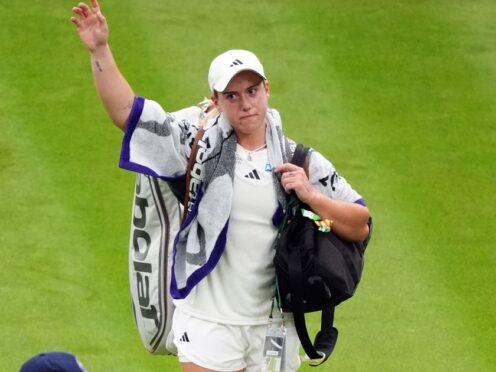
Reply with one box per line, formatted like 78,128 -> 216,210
71,0 -> 109,51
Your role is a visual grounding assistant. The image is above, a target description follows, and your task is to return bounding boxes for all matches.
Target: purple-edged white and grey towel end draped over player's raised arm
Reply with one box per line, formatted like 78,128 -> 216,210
119,97 -> 200,180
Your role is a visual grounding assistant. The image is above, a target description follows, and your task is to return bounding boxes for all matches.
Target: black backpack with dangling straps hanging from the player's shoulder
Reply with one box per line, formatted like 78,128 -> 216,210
274,144 -> 372,366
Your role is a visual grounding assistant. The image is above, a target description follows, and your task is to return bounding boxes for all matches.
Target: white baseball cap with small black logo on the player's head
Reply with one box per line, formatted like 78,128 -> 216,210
208,49 -> 267,92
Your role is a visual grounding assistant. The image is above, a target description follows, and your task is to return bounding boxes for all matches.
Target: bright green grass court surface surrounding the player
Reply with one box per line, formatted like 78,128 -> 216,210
0,0 -> 496,372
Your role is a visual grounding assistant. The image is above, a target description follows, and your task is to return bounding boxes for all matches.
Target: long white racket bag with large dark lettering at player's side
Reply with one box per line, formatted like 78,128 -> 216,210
129,174 -> 182,354
